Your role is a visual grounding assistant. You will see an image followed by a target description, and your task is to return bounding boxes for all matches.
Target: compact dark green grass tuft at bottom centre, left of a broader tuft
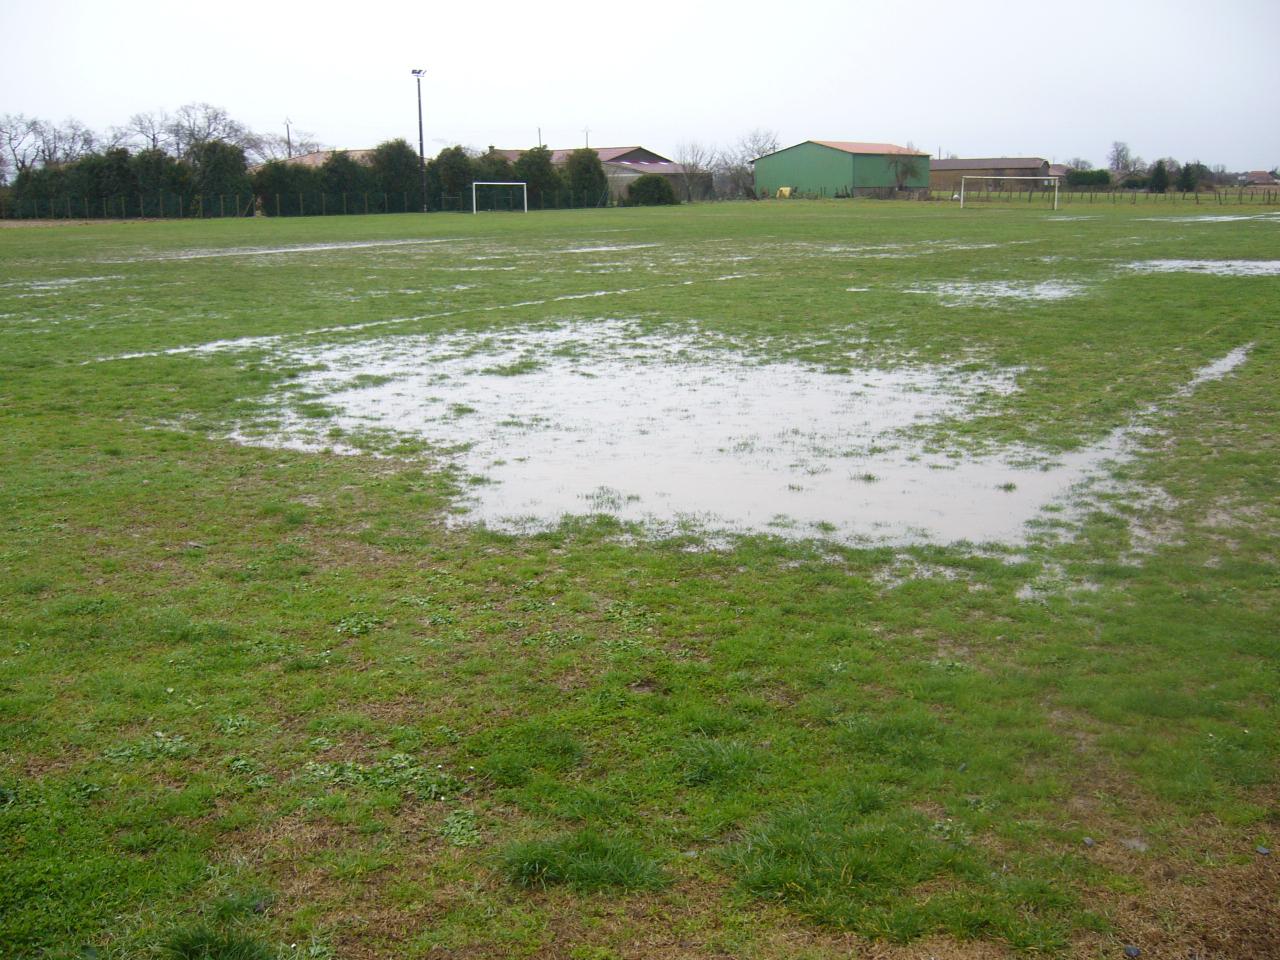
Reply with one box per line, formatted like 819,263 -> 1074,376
503,831 -> 668,892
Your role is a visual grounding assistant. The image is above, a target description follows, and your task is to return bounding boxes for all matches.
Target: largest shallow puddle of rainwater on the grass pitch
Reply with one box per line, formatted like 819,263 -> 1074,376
236,320 -> 1244,544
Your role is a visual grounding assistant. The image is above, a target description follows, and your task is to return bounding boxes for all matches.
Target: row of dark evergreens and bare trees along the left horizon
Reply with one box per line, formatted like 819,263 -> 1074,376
0,104 -> 675,215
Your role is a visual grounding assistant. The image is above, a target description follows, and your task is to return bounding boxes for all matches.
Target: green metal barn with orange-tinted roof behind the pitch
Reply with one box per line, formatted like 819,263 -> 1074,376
755,140 -> 929,197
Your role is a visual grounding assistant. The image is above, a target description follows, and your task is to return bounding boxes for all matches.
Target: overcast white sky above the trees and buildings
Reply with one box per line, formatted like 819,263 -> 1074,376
0,0 -> 1280,170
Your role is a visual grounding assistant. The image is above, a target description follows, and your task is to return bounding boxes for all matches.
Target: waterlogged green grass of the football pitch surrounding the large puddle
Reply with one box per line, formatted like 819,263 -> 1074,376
0,201 -> 1280,960
